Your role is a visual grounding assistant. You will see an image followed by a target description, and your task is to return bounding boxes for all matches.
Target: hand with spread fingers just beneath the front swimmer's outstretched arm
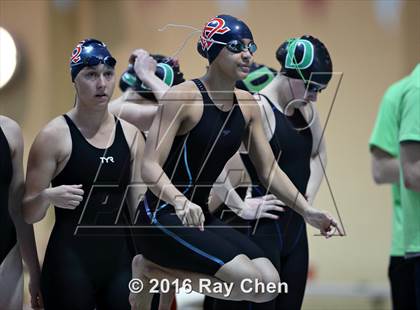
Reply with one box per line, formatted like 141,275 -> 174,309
238,194 -> 285,220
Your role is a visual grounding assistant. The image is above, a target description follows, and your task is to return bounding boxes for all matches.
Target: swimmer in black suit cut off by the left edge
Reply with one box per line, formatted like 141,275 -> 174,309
0,115 -> 43,310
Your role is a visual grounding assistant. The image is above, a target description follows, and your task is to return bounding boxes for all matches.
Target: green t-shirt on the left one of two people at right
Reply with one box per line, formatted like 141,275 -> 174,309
369,77 -> 410,256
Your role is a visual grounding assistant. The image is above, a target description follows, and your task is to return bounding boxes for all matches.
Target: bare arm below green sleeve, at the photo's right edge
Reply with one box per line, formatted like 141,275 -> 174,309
400,141 -> 420,192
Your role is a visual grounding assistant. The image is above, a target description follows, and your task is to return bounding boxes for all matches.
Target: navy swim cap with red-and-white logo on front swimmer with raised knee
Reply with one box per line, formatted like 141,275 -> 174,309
197,15 -> 254,63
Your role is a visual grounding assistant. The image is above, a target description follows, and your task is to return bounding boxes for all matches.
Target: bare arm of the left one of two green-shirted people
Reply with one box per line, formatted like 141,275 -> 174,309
370,146 -> 400,184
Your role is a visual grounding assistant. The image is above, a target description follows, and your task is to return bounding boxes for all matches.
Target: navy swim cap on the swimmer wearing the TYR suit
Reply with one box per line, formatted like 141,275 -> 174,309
70,39 -> 117,82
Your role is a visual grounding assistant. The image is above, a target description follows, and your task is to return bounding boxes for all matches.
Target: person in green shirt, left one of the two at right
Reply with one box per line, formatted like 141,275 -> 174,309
369,64 -> 416,309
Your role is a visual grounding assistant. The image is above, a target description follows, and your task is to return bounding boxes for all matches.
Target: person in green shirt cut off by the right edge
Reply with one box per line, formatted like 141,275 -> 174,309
397,64 -> 420,310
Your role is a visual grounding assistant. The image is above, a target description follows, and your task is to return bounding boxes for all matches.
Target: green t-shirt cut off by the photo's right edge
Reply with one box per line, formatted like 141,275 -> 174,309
398,64 -> 420,254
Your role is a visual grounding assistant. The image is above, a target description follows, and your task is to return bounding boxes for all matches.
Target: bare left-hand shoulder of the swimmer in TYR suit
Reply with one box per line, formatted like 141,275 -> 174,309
31,116 -> 72,157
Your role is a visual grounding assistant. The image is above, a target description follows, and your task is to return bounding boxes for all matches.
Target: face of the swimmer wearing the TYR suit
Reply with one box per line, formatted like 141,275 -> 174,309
74,64 -> 115,104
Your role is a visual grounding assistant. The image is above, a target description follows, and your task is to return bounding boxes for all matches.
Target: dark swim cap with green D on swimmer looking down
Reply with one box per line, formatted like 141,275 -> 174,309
276,35 -> 333,85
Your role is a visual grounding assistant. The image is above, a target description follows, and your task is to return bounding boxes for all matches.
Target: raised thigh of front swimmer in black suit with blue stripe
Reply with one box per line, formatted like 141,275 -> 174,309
136,206 -> 258,275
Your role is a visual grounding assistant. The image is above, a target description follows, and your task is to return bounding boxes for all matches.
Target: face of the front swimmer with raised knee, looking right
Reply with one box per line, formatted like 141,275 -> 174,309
213,39 -> 253,81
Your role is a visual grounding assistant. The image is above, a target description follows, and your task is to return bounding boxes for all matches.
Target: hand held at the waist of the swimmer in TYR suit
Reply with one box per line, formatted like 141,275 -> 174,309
45,184 -> 84,210
